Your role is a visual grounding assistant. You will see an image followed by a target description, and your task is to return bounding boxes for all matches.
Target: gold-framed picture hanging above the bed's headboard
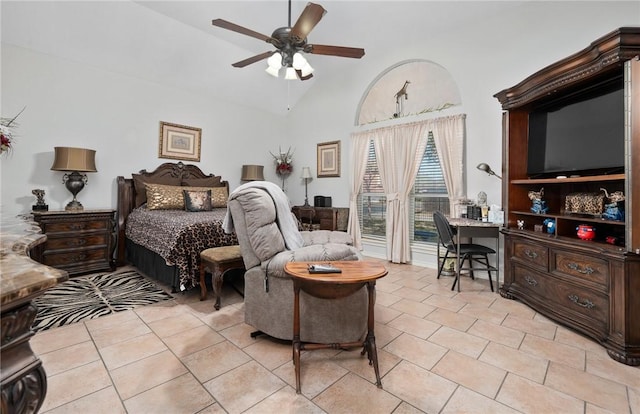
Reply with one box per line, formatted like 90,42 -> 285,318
158,121 -> 202,161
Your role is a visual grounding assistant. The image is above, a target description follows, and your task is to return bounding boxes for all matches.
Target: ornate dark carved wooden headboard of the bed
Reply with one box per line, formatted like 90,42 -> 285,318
117,162 -> 229,266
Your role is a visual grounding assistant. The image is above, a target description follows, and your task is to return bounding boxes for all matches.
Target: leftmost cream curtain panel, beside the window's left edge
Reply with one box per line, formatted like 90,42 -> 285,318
347,132 -> 370,250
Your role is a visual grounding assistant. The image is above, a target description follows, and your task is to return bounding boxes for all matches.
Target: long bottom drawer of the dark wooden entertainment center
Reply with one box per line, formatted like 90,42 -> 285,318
514,266 -> 609,335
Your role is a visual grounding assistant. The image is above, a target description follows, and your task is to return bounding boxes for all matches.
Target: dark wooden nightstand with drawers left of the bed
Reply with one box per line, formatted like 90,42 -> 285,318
31,210 -> 116,276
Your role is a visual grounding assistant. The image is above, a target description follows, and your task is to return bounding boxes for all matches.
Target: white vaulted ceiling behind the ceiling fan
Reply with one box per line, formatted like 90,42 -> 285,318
0,0 -> 523,114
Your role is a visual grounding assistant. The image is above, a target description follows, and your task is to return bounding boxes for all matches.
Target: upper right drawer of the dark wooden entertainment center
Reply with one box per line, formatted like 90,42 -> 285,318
549,251 -> 609,289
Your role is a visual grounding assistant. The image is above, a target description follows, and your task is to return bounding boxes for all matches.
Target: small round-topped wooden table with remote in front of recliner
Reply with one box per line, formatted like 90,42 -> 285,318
284,260 -> 387,394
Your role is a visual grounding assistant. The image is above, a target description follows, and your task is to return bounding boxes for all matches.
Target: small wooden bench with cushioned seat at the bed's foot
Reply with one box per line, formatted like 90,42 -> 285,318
200,245 -> 245,310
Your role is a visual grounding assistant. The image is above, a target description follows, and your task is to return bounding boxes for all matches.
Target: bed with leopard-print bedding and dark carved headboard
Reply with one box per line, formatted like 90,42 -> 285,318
117,162 -> 238,292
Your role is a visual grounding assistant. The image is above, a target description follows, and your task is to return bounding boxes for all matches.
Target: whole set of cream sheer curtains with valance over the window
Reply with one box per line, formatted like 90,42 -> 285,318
349,115 -> 466,263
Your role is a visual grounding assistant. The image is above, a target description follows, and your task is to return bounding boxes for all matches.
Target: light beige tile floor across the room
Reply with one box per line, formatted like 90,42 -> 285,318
31,259 -> 640,414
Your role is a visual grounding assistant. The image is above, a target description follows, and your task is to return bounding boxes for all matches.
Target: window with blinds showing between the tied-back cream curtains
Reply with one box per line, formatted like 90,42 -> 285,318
358,132 -> 449,243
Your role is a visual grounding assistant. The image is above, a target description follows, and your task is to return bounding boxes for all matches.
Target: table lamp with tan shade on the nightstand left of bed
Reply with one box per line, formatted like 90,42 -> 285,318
51,147 -> 98,211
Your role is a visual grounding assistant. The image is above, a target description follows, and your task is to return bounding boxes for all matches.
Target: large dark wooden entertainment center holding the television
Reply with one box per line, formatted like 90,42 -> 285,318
495,27 -> 640,365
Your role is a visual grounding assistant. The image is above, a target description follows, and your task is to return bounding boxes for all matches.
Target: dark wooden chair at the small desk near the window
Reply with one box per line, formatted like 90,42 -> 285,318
433,211 -> 497,292
